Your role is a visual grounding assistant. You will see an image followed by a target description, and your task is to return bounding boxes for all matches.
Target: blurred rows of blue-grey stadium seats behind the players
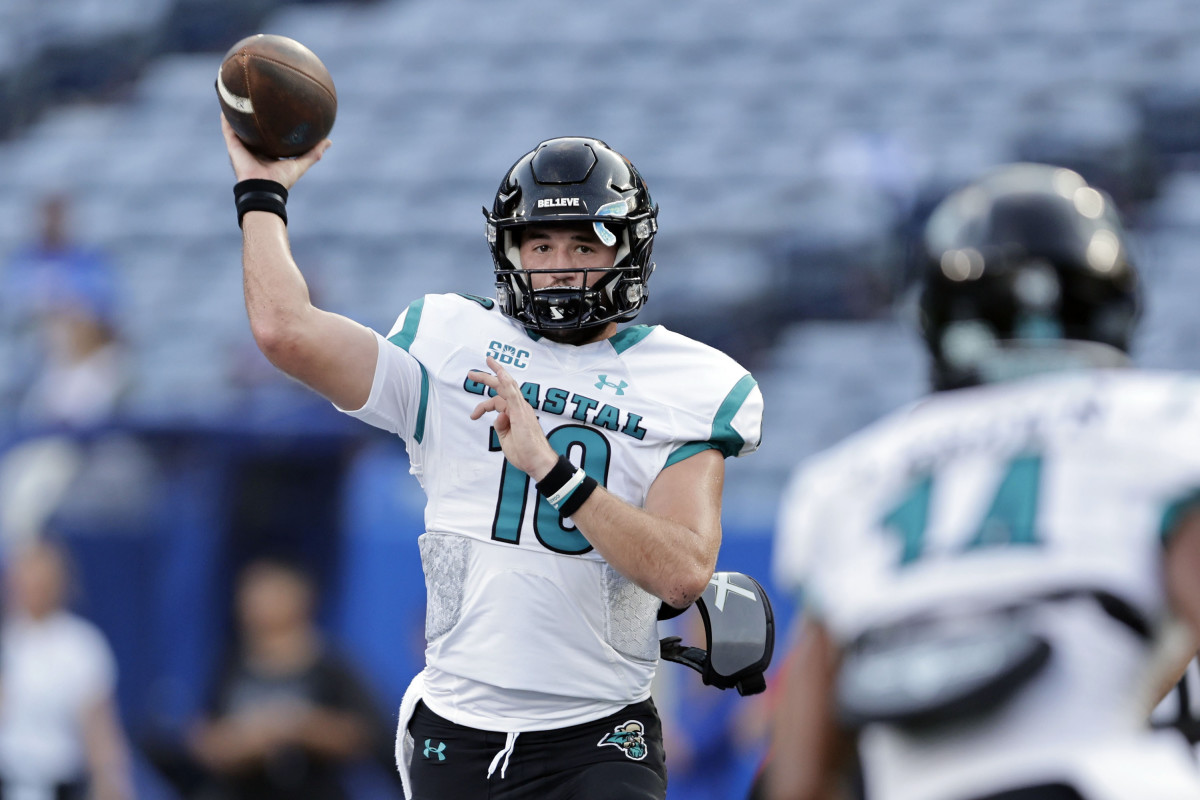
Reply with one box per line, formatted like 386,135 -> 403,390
0,0 -> 1200,513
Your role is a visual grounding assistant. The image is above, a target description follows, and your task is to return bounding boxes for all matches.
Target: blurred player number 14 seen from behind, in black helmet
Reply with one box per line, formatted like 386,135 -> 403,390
767,164 -> 1200,800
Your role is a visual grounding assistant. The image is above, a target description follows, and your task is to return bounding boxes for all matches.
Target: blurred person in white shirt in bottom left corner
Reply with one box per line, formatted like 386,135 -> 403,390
0,540 -> 132,800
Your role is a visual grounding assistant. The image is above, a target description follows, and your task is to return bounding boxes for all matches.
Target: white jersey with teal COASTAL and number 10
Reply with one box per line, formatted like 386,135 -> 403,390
338,295 -> 762,732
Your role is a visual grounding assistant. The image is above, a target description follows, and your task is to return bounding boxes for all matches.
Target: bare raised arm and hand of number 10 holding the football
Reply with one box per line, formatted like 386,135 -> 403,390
221,116 -> 378,409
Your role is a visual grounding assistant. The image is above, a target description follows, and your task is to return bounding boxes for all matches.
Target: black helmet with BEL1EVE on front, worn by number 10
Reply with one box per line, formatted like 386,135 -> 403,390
484,137 -> 659,332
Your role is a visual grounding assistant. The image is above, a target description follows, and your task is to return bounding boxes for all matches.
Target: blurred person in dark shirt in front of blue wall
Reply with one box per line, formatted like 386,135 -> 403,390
188,560 -> 395,800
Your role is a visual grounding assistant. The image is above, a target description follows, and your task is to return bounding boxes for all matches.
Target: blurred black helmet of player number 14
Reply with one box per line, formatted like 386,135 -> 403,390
920,163 -> 1139,390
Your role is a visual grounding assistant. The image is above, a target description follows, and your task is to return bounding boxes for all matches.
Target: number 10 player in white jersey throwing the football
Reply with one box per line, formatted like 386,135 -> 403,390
224,118 -> 762,800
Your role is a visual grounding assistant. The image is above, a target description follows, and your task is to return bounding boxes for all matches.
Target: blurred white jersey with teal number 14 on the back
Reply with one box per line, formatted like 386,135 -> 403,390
775,371 -> 1200,800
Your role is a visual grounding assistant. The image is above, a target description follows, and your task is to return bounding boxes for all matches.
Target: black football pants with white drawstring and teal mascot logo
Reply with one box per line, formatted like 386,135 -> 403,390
408,700 -> 667,800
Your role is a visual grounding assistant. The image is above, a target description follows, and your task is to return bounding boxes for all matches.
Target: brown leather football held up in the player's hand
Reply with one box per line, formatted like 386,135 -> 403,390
217,34 -> 337,158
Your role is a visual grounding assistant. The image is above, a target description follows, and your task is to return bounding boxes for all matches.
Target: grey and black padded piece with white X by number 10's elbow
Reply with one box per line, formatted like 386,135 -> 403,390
659,572 -> 775,694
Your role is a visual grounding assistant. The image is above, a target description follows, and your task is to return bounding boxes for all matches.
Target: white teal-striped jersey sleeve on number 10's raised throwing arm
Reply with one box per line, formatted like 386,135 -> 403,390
334,300 -> 430,444
